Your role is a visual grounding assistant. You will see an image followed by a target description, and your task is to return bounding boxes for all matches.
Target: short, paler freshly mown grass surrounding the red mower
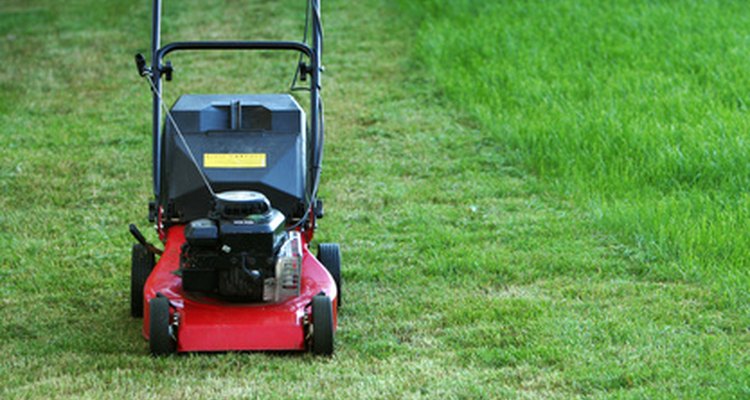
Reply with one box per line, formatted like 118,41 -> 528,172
0,0 -> 750,399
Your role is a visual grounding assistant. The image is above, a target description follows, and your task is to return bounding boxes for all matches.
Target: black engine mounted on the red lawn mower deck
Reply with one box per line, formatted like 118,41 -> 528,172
180,191 -> 302,302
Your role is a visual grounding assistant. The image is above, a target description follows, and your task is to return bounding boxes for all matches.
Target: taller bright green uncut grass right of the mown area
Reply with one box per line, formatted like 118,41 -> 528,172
403,0 -> 750,309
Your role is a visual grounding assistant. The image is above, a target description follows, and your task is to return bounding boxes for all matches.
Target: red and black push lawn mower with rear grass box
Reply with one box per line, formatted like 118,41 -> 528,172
130,0 -> 341,355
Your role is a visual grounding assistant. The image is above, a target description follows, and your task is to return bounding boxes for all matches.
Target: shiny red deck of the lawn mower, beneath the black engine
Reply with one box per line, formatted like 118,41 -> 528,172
143,225 -> 338,352
